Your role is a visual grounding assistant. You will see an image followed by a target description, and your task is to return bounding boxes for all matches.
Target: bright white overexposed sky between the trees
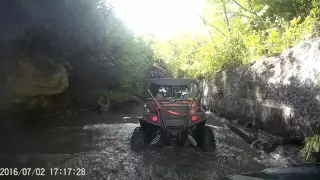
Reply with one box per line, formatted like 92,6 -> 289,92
107,0 -> 204,39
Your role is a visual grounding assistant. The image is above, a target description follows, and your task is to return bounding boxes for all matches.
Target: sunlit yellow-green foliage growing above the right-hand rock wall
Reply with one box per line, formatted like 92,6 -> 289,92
154,0 -> 320,78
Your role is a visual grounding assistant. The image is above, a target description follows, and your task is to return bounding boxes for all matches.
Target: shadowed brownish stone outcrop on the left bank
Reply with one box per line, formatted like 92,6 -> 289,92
0,55 -> 68,110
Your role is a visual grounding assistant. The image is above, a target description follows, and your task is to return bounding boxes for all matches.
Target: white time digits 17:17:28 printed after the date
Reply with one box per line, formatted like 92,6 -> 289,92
49,168 -> 86,176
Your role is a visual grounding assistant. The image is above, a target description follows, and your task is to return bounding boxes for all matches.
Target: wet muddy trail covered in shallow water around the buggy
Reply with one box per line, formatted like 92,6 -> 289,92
0,107 -> 288,180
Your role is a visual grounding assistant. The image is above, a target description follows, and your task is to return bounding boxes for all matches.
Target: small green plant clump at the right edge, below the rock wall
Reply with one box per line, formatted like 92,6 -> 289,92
302,135 -> 320,161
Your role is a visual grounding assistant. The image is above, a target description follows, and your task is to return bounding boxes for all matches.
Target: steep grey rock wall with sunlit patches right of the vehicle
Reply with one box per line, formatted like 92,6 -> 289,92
202,38 -> 320,140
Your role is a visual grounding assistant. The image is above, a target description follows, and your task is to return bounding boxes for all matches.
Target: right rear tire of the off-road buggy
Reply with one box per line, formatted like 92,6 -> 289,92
198,127 -> 216,152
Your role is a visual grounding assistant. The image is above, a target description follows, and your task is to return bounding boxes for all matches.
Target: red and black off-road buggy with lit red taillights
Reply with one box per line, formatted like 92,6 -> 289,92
131,78 -> 215,151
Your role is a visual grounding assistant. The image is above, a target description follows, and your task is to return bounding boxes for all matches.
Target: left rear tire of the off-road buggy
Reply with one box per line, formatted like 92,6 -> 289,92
131,127 -> 147,151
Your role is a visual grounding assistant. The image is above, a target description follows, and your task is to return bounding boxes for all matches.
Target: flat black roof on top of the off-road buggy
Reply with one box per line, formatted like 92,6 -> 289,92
149,78 -> 195,86
